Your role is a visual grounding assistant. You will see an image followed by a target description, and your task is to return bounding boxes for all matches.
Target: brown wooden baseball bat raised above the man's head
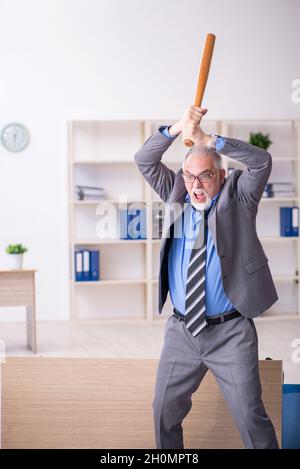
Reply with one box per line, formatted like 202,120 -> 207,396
184,33 -> 216,147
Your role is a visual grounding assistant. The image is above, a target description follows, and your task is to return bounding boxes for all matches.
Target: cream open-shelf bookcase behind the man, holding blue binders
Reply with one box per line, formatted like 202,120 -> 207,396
68,119 -> 300,324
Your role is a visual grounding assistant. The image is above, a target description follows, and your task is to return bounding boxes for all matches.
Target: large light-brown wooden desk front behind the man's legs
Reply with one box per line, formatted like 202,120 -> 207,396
1,357 -> 282,449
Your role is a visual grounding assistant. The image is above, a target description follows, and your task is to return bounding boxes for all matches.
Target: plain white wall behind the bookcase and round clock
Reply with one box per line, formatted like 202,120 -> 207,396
0,0 -> 300,320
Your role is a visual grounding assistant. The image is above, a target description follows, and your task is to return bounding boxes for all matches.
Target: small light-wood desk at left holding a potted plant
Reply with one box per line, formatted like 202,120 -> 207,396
0,269 -> 37,353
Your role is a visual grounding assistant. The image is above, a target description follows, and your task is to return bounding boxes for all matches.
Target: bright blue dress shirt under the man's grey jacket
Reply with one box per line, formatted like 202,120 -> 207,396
161,128 -> 234,316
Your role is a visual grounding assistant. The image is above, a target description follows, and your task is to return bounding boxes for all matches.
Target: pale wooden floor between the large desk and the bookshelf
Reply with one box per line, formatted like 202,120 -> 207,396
0,318 -> 300,384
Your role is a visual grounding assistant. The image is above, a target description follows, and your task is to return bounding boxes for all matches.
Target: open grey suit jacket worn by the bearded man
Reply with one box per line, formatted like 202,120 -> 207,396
134,130 -> 278,318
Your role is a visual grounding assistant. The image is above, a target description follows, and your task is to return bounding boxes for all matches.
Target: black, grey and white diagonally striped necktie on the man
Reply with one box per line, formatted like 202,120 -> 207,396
185,210 -> 207,337
